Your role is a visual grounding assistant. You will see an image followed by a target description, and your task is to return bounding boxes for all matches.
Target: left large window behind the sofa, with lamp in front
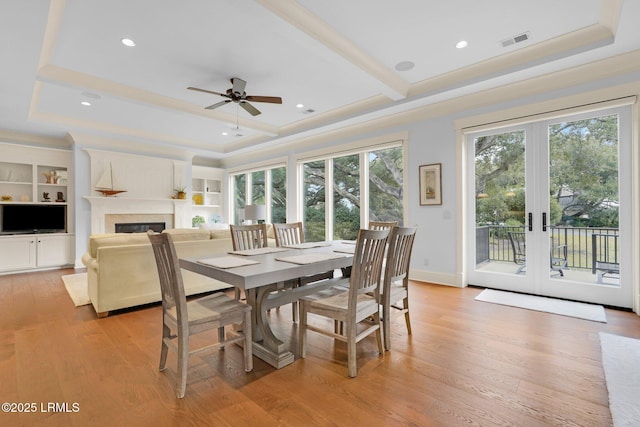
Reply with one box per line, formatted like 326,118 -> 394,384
231,166 -> 287,224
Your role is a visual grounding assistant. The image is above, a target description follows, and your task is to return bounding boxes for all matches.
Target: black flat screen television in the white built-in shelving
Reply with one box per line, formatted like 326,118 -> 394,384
0,203 -> 67,234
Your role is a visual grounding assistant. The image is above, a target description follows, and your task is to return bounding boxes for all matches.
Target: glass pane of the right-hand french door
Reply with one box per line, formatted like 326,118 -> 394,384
548,115 -> 620,286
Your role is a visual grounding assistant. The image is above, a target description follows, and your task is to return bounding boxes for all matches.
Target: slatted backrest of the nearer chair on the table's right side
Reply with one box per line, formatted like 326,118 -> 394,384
349,229 -> 391,315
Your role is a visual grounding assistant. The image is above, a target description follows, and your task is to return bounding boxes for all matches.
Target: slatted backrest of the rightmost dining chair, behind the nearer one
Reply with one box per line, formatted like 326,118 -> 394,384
383,227 -> 418,296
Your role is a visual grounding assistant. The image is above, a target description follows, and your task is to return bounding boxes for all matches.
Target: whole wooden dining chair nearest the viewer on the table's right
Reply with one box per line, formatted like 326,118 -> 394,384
298,229 -> 390,378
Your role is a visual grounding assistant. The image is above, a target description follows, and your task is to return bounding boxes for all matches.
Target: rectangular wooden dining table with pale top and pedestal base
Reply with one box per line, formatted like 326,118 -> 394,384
180,240 -> 355,369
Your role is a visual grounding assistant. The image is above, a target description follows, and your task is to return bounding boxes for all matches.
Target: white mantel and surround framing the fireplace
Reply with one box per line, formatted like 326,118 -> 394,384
84,196 -> 191,234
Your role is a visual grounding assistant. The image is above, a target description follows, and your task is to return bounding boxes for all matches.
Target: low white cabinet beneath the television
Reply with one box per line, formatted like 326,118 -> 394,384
0,233 -> 74,272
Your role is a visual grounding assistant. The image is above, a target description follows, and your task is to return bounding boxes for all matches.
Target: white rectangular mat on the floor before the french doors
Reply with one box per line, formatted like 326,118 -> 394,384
476,289 -> 607,323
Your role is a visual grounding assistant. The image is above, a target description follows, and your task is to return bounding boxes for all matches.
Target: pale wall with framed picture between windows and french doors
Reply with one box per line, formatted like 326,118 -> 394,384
218,73 -> 640,286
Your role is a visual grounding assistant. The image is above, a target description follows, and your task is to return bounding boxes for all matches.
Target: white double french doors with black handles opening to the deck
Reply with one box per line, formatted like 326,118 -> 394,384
466,107 -> 632,307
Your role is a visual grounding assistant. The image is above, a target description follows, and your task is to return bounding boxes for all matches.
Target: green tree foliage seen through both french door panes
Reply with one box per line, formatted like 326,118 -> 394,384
475,116 -> 618,227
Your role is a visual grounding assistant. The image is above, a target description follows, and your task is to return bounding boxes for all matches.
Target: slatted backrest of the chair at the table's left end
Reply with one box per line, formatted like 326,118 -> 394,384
147,230 -> 187,326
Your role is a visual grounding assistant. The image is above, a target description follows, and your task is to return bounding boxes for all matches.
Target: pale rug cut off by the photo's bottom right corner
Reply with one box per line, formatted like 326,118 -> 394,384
600,332 -> 640,427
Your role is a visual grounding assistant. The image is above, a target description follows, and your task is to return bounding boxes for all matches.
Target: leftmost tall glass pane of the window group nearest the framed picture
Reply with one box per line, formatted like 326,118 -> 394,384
302,160 -> 325,242
